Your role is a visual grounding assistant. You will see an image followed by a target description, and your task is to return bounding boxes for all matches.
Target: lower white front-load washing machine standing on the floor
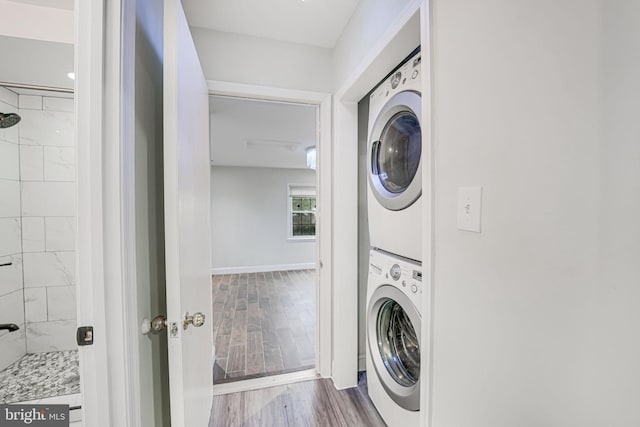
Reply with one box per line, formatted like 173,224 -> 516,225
366,249 -> 422,427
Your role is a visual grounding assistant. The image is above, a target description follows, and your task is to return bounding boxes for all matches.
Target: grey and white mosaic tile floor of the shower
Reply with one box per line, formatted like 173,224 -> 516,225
0,350 -> 80,403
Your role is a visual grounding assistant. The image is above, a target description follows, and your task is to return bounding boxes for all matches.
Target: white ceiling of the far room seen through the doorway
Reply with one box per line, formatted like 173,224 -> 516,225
209,96 -> 317,168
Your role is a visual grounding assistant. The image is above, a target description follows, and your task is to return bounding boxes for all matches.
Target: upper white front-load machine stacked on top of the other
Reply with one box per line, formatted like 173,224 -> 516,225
367,52 -> 423,261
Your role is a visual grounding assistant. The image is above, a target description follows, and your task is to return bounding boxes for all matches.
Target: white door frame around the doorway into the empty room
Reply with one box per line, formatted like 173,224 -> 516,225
207,80 -> 333,378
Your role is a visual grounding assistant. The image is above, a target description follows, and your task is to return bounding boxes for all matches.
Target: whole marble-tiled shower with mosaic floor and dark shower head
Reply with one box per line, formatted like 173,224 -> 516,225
0,83 -> 81,407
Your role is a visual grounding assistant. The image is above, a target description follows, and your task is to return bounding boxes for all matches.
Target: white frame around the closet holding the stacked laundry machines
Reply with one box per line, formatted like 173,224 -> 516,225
332,0 -> 424,394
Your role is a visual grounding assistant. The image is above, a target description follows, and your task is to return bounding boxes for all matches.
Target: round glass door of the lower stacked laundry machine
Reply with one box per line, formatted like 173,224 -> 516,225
367,285 -> 420,411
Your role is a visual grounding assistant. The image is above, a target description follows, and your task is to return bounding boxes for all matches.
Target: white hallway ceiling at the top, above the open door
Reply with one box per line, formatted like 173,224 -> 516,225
182,0 -> 358,49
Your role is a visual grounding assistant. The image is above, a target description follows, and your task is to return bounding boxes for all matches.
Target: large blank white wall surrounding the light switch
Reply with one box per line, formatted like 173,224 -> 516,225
432,0 -> 628,427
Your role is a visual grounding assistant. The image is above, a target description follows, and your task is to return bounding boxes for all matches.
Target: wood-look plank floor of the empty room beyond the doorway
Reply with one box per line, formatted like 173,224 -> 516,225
212,270 -> 316,384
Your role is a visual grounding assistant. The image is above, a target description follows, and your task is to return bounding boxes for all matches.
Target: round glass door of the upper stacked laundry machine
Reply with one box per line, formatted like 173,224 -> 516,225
369,91 -> 422,211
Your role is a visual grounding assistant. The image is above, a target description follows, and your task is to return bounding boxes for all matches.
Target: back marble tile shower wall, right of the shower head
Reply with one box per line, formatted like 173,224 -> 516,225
18,95 -> 76,353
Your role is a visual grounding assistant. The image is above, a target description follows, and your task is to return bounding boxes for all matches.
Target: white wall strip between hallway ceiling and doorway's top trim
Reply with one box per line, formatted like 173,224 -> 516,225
191,27 -> 332,92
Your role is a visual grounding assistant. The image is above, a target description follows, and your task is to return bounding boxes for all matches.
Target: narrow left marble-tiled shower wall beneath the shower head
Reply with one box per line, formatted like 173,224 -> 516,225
0,87 -> 26,370
